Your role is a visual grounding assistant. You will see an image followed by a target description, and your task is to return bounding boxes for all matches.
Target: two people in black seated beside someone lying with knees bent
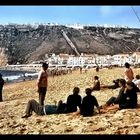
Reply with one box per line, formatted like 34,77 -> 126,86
22,87 -> 100,118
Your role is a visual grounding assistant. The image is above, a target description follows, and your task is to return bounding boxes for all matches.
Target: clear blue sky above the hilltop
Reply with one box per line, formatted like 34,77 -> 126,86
0,5 -> 140,28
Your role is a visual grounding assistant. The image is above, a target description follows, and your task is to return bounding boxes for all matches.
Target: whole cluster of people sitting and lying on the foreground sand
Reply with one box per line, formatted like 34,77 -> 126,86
22,63 -> 140,118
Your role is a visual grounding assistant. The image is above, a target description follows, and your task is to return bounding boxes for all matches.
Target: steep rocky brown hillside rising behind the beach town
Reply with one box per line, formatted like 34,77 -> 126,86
0,24 -> 140,65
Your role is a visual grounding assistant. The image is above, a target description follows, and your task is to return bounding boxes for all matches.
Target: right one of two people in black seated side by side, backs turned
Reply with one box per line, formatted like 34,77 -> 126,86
79,88 -> 100,117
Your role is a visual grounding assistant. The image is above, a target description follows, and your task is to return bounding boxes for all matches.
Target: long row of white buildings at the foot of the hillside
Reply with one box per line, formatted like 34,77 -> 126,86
45,52 -> 137,67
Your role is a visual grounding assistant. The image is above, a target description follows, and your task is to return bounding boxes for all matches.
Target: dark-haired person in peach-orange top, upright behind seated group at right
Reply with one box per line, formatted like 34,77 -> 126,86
124,62 -> 134,81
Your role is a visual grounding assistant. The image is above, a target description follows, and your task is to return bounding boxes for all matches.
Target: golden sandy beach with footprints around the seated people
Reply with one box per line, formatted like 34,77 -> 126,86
0,68 -> 140,134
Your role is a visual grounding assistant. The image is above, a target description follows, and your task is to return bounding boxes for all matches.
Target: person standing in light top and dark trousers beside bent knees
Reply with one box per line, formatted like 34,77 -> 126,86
37,63 -> 48,106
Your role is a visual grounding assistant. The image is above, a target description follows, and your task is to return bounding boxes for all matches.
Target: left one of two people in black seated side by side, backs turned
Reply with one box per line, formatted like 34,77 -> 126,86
58,87 -> 82,113
